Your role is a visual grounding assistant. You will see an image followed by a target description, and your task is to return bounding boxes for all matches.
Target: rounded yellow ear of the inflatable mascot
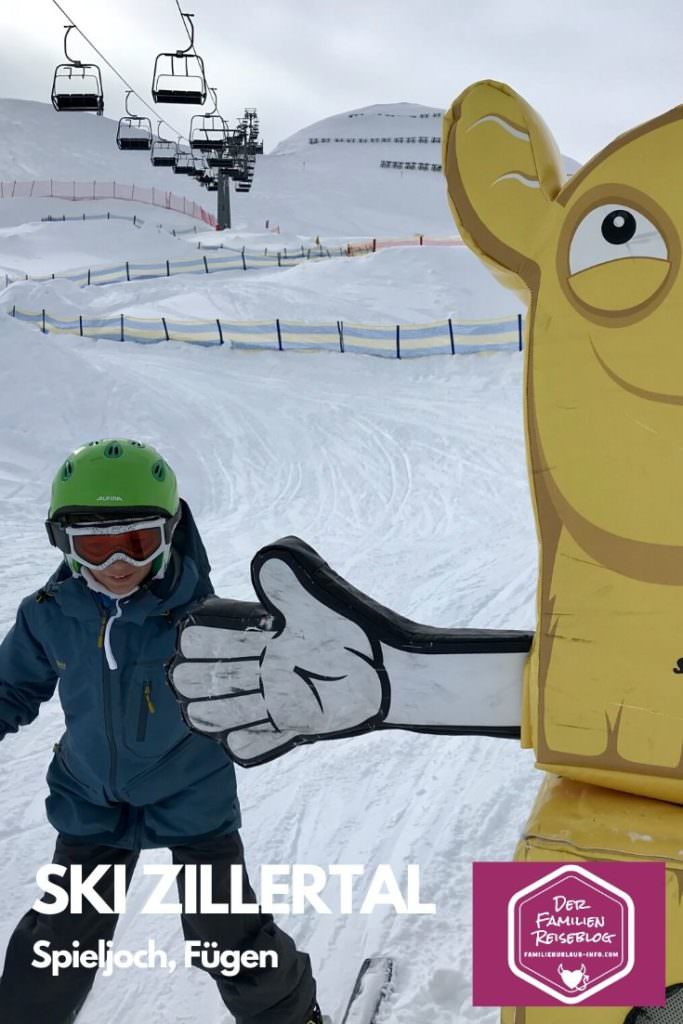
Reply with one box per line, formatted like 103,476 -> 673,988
442,82 -> 564,298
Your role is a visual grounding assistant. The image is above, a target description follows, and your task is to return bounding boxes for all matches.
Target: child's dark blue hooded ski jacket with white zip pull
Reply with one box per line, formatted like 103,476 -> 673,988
0,502 -> 241,849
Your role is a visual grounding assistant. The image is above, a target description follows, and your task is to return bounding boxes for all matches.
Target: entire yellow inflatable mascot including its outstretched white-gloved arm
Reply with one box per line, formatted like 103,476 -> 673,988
169,75 -> 683,1024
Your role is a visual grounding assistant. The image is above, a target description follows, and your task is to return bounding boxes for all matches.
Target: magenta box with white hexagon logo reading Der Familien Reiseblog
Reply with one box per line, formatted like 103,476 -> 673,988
472,861 -> 666,1007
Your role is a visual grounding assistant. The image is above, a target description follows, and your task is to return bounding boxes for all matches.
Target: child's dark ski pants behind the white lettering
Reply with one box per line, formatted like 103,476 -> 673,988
0,833 -> 315,1024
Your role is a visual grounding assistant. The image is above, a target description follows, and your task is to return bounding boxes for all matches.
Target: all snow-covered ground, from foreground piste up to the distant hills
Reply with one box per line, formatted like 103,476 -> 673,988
0,92 -> 569,1024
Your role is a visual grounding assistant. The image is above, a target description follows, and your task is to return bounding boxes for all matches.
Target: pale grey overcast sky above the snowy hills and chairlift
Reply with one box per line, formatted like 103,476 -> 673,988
0,0 -> 683,162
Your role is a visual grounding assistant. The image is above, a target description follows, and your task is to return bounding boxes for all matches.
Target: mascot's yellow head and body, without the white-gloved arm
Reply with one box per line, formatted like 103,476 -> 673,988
443,82 -> 683,1024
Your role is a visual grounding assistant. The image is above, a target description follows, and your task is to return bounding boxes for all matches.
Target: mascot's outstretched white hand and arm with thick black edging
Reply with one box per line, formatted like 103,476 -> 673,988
169,538 -> 530,766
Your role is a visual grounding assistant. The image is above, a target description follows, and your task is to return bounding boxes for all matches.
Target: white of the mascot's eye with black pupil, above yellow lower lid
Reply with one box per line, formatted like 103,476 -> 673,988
569,203 -> 669,274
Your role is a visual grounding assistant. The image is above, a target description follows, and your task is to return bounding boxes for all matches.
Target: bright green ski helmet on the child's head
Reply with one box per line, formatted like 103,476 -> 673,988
45,438 -> 181,578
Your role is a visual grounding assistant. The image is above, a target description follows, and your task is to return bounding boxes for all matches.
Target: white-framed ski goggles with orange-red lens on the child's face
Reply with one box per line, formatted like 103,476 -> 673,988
47,516 -> 178,569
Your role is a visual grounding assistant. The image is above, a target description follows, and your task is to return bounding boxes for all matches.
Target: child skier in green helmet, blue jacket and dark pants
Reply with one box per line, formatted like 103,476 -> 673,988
0,439 -> 323,1024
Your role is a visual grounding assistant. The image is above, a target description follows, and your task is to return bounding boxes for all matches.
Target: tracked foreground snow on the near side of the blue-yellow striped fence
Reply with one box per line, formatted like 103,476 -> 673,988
0,264 -> 538,1024
